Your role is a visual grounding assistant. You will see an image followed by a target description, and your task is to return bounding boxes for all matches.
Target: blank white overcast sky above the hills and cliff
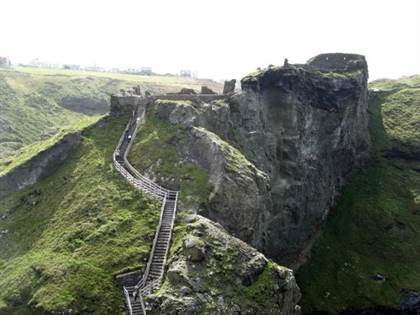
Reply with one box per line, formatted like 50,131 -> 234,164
0,0 -> 420,79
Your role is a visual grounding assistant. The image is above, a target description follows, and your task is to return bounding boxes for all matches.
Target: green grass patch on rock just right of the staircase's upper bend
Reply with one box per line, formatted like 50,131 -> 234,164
129,105 -> 210,207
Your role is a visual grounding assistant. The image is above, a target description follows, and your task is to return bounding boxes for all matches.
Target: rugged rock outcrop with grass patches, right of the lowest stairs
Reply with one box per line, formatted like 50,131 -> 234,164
145,216 -> 300,315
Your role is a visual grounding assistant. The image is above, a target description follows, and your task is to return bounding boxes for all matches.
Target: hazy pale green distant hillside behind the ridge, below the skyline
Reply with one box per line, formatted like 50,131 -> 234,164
0,67 -> 220,174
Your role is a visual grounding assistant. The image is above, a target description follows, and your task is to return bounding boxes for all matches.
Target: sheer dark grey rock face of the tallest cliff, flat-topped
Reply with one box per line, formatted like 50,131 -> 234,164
231,54 -> 370,266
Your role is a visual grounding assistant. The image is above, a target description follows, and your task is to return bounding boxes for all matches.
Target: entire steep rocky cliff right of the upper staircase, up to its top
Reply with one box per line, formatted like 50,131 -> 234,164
130,54 -> 370,266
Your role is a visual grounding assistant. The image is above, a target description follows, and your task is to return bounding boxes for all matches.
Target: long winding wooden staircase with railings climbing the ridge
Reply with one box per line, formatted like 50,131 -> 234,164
113,110 -> 179,315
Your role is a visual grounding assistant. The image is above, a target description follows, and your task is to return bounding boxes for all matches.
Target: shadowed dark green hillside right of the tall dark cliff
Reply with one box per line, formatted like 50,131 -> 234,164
297,76 -> 420,314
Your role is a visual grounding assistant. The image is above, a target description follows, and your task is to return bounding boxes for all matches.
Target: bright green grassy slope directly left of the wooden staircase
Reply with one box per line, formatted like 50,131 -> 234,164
0,117 -> 160,314
